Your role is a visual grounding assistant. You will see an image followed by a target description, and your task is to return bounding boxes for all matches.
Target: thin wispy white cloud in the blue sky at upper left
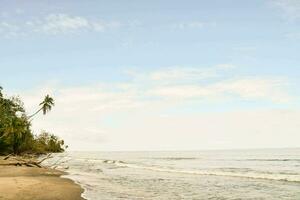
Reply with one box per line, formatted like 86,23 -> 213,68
0,13 -> 122,37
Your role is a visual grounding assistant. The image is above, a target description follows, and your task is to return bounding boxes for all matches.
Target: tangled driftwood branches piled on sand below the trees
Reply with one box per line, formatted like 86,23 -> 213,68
0,154 -> 52,168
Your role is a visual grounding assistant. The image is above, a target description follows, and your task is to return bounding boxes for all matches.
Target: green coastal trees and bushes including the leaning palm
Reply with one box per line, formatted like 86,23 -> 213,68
0,87 -> 67,155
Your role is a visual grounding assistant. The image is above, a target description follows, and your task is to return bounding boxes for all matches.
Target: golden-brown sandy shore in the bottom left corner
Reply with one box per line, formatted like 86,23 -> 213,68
0,163 -> 83,200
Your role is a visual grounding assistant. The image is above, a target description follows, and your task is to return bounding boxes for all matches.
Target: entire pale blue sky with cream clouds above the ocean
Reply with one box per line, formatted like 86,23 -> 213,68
0,0 -> 300,151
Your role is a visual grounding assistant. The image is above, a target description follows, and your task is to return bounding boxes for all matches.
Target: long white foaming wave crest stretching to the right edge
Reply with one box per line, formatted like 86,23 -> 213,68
114,161 -> 300,182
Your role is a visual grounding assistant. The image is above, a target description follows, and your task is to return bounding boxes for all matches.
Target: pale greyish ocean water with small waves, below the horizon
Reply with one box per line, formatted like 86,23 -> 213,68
46,149 -> 300,200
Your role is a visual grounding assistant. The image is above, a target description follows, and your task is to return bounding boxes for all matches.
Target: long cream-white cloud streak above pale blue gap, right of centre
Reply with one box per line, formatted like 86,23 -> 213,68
149,78 -> 291,103
